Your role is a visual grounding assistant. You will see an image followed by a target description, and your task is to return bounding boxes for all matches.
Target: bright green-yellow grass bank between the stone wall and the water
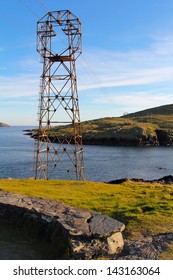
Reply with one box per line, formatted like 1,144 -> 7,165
0,179 -> 173,238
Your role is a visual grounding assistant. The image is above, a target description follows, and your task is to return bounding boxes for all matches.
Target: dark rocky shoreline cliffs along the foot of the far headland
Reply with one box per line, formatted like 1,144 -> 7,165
24,123 -> 173,147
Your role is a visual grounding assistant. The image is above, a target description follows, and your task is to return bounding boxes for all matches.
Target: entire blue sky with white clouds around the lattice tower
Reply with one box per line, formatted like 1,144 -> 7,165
0,0 -> 173,125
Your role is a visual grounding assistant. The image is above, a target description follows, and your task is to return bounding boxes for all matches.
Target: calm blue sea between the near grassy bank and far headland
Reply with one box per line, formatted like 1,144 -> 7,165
0,127 -> 173,181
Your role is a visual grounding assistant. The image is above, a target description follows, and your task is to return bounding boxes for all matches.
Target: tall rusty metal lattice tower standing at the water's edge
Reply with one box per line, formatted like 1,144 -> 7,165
35,10 -> 85,180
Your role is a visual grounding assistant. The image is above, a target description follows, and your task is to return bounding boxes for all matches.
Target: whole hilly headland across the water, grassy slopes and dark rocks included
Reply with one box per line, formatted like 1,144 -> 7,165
31,104 -> 173,146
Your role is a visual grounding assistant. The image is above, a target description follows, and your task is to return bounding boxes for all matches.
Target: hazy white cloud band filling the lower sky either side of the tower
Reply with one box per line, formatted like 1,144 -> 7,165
0,37 -> 173,123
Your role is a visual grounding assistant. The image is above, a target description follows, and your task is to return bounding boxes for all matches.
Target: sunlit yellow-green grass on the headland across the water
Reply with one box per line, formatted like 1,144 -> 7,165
47,114 -> 173,144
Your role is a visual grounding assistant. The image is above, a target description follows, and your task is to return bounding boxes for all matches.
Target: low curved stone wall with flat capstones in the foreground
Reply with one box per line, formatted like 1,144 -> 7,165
0,192 -> 125,259
